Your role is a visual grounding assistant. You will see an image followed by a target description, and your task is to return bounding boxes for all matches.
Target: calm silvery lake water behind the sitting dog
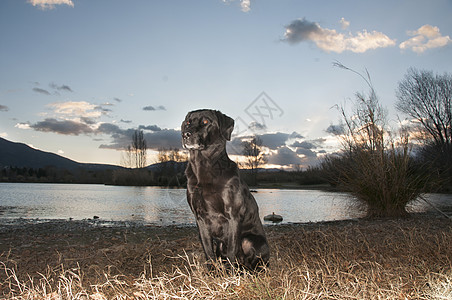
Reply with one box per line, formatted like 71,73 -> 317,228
0,183 -> 452,225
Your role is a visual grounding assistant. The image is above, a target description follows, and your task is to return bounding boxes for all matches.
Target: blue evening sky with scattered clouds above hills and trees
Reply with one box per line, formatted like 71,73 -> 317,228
0,0 -> 452,168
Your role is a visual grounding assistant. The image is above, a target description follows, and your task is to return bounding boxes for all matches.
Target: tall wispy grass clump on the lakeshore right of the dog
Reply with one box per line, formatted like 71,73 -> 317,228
322,63 -> 427,217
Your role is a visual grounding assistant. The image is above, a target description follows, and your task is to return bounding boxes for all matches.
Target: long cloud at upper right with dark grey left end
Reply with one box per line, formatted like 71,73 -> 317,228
283,18 -> 395,53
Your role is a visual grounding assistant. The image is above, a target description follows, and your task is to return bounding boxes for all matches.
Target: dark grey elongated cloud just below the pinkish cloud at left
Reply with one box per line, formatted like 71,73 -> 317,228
30,118 -> 93,135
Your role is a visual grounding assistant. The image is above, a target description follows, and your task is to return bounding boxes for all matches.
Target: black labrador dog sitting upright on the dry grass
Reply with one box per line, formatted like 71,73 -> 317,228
181,109 -> 270,270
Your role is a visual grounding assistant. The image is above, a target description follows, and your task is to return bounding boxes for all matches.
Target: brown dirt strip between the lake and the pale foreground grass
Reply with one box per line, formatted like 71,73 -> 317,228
0,215 -> 452,295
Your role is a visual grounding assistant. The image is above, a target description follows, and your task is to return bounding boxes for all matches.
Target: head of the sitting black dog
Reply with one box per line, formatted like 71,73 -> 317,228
181,109 -> 234,150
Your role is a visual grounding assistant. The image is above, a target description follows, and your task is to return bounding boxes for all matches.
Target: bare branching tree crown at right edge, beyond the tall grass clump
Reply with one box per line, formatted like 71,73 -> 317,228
396,68 -> 452,150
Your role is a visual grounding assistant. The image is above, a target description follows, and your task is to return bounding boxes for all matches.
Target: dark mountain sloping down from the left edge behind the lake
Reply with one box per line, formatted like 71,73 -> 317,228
0,138 -> 121,170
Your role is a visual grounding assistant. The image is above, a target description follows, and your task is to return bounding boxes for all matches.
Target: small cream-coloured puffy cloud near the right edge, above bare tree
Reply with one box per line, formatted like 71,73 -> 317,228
399,24 -> 452,54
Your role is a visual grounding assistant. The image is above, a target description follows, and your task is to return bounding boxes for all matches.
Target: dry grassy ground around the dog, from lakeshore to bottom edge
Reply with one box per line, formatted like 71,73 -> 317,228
0,216 -> 452,299
